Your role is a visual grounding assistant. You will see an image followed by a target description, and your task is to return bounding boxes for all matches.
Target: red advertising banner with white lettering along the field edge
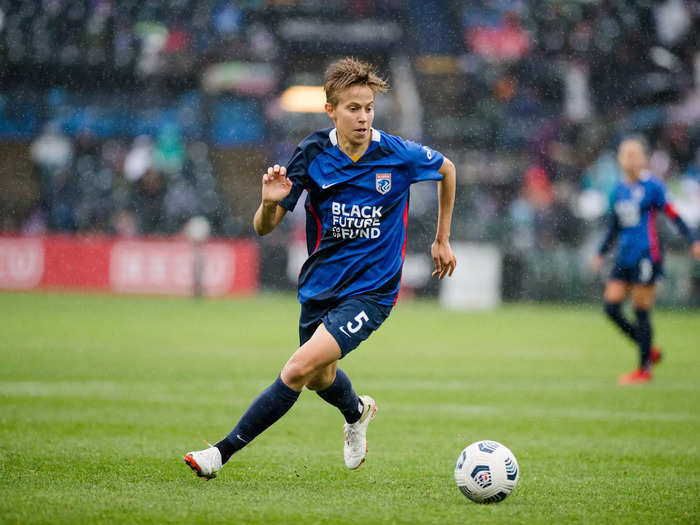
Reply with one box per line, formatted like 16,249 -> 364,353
0,236 -> 259,296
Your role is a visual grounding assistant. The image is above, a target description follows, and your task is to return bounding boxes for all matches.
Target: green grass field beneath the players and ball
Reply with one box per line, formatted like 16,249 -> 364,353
0,294 -> 700,524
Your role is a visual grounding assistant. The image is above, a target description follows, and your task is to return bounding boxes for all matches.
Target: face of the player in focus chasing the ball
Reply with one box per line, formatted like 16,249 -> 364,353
326,85 -> 374,146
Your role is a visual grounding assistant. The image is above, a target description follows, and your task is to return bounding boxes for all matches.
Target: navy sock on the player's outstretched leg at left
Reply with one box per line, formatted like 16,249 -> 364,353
215,376 -> 301,463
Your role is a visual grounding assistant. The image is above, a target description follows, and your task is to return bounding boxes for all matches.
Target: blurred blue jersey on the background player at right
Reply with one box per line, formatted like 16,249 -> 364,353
600,173 -> 693,268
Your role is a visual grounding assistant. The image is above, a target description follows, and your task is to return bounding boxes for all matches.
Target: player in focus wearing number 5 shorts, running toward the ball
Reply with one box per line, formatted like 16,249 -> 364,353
184,58 -> 457,479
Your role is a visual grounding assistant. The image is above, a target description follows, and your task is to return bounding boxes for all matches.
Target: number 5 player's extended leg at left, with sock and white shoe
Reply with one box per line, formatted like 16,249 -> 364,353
185,325 -> 341,478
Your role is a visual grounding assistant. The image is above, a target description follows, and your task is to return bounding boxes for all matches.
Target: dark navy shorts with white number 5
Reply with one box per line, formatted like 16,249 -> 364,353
299,295 -> 392,359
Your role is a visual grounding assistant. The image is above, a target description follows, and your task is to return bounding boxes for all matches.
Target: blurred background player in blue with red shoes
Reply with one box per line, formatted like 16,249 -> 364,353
592,137 -> 700,385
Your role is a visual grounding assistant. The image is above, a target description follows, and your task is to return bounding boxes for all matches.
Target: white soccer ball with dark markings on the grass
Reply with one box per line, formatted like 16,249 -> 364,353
455,441 -> 520,503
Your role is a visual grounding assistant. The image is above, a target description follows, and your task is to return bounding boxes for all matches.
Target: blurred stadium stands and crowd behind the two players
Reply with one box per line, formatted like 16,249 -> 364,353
0,0 -> 700,306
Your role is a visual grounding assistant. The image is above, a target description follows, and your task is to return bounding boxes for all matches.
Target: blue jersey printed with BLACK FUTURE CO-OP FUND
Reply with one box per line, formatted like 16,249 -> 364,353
280,128 -> 444,305
